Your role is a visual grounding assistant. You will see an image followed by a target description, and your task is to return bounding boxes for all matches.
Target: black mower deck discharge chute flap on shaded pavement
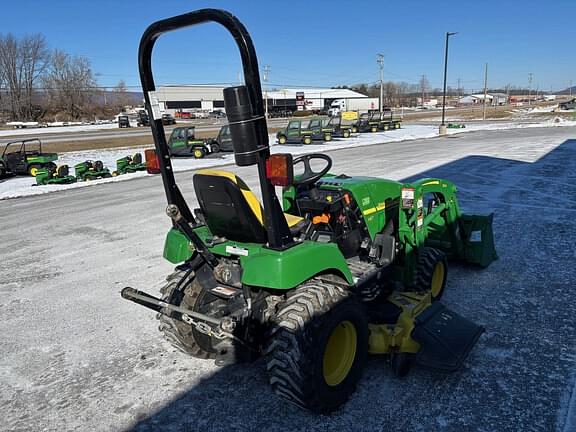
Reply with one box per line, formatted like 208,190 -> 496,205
411,302 -> 484,372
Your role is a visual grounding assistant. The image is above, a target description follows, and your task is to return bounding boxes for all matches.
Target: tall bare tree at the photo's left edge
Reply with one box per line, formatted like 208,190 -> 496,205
0,33 -> 49,120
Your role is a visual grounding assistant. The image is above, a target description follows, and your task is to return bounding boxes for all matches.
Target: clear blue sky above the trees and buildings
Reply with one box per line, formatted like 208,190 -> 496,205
0,0 -> 576,91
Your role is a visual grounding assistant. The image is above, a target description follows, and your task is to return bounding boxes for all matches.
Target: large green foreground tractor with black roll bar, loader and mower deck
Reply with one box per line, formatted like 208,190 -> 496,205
121,9 -> 496,413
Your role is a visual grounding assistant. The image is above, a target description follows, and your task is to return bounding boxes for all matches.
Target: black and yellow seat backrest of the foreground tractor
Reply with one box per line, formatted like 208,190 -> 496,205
193,169 -> 268,243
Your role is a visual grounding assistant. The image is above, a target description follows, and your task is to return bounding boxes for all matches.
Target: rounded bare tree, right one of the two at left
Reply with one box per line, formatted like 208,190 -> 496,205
43,50 -> 96,119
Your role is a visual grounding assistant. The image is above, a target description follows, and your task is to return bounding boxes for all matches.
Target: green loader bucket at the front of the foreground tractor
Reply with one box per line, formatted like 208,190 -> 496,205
460,213 -> 498,267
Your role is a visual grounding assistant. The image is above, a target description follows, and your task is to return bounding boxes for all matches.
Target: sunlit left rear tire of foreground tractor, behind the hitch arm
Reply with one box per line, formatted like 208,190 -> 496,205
156,270 -> 217,359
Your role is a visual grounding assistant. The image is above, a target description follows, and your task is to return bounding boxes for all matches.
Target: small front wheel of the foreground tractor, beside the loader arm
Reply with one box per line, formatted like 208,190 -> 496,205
414,247 -> 448,301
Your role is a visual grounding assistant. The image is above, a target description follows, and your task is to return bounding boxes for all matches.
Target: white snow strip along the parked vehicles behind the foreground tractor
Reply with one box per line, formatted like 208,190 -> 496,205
0,118 -> 576,200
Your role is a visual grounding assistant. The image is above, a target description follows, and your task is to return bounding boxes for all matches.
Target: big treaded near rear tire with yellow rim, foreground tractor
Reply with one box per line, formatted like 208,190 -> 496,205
264,280 -> 368,413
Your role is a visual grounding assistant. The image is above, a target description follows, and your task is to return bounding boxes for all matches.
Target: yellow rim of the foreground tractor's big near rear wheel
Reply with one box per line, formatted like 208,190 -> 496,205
322,321 -> 357,387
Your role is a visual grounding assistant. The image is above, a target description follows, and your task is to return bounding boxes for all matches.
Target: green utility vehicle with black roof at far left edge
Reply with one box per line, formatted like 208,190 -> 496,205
0,138 -> 58,177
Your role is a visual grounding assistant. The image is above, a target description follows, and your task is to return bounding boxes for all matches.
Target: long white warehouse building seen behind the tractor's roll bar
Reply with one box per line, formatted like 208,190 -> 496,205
156,85 -> 366,116
